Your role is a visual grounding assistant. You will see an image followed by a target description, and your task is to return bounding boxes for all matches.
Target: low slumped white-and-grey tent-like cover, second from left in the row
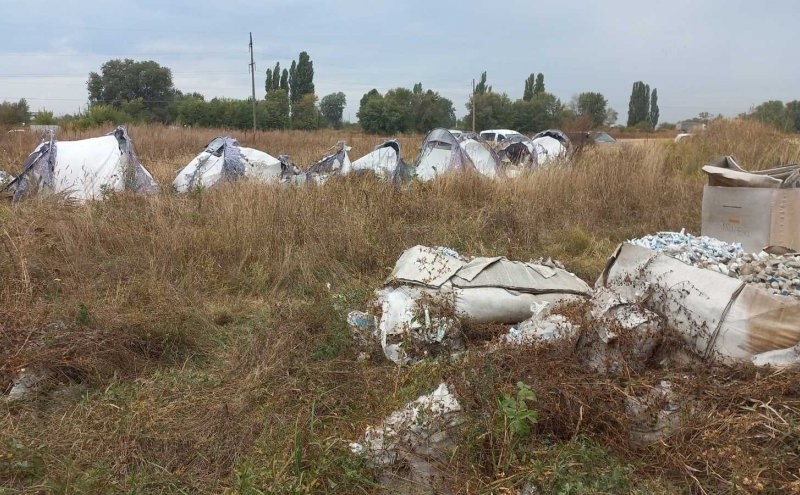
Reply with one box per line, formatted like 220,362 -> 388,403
172,136 -> 283,192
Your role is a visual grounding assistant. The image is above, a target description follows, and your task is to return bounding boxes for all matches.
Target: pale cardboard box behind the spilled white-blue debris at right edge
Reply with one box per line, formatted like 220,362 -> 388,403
701,186 -> 800,252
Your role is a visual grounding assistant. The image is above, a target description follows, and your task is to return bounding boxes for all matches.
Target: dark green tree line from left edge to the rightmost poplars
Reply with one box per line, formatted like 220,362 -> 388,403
0,51 -> 676,134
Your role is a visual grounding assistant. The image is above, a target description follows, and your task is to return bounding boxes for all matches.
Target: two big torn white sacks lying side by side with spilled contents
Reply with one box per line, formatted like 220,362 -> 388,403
348,242 -> 800,371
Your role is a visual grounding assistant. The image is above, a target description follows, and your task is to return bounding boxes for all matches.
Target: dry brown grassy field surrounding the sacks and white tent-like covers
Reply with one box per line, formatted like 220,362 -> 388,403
0,121 -> 800,494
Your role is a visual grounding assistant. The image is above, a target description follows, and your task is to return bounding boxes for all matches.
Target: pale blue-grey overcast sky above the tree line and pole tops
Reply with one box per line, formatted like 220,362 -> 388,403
0,0 -> 800,123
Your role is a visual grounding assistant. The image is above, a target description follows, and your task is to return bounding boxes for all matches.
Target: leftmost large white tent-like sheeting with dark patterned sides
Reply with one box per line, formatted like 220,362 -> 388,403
8,127 -> 158,201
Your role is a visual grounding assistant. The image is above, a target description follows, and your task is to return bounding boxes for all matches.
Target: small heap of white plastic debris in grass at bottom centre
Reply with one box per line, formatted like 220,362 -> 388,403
350,383 -> 464,486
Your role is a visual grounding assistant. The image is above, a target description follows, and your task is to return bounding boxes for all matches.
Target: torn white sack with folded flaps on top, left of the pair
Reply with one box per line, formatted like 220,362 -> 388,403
366,246 -> 591,364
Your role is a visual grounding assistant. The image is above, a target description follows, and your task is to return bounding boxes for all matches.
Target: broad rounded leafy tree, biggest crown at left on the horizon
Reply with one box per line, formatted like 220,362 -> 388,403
86,59 -> 175,122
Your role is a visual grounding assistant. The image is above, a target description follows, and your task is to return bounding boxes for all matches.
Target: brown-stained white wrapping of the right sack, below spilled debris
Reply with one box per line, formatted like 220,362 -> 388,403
597,243 -> 800,362
